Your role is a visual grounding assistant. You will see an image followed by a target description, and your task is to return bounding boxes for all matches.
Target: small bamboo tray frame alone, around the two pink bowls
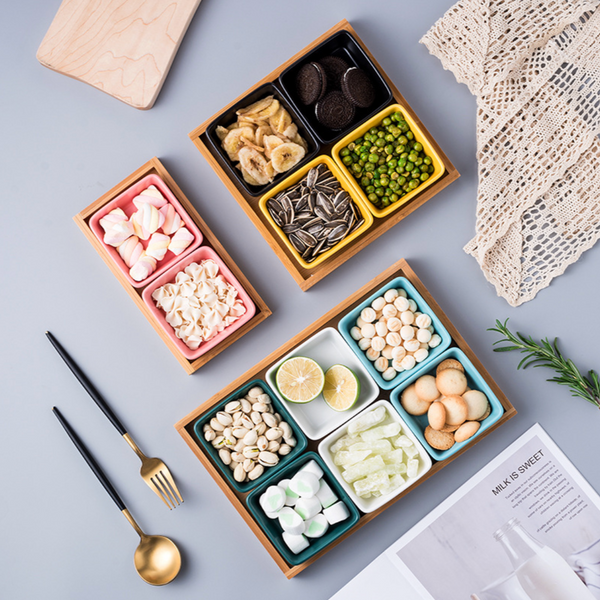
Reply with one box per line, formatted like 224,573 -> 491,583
73,158 -> 271,374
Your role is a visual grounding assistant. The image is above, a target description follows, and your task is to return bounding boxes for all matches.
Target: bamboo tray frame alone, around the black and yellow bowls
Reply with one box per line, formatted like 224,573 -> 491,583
189,20 -> 460,291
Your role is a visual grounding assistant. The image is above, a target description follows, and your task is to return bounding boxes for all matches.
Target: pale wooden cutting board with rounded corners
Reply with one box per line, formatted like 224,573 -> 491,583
36,0 -> 200,110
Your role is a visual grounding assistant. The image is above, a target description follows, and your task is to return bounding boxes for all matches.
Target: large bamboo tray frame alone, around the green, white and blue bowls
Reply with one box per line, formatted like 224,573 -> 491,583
175,260 -> 517,579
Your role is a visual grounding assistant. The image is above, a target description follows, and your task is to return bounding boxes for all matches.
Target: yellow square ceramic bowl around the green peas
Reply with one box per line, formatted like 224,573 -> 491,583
331,104 -> 445,218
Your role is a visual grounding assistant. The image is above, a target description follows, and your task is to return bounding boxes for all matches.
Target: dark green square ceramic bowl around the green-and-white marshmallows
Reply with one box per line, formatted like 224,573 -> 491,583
246,452 -> 360,565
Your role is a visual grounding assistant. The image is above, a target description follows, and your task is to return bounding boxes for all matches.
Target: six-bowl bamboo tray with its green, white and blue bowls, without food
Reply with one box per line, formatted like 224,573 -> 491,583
175,260 -> 516,578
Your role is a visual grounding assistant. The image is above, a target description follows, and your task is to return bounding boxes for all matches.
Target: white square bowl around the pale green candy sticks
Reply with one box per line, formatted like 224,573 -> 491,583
319,400 -> 431,513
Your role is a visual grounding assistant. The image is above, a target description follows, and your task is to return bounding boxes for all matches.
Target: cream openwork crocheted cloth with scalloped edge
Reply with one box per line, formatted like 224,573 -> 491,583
421,0 -> 600,306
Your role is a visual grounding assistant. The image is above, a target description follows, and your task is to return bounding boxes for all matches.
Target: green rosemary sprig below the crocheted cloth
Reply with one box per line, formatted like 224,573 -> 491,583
488,319 -> 600,408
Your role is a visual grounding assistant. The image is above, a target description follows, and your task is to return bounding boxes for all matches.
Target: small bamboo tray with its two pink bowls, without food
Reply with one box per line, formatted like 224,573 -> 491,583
74,158 -> 271,374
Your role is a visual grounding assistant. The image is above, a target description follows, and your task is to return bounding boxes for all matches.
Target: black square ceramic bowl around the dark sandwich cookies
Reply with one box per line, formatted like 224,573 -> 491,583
279,31 -> 392,144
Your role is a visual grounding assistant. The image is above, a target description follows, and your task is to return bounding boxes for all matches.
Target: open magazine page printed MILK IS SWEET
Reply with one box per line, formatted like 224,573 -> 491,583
331,425 -> 600,600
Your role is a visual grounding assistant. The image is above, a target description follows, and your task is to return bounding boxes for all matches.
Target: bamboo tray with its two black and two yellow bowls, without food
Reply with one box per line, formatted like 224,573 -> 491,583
190,20 -> 459,291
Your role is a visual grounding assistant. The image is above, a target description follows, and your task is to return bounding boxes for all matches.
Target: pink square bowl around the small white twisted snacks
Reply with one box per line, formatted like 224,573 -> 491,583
142,246 -> 256,360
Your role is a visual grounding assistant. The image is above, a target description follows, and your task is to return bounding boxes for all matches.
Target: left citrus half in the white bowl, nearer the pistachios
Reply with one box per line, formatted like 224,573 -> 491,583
275,356 -> 325,404
